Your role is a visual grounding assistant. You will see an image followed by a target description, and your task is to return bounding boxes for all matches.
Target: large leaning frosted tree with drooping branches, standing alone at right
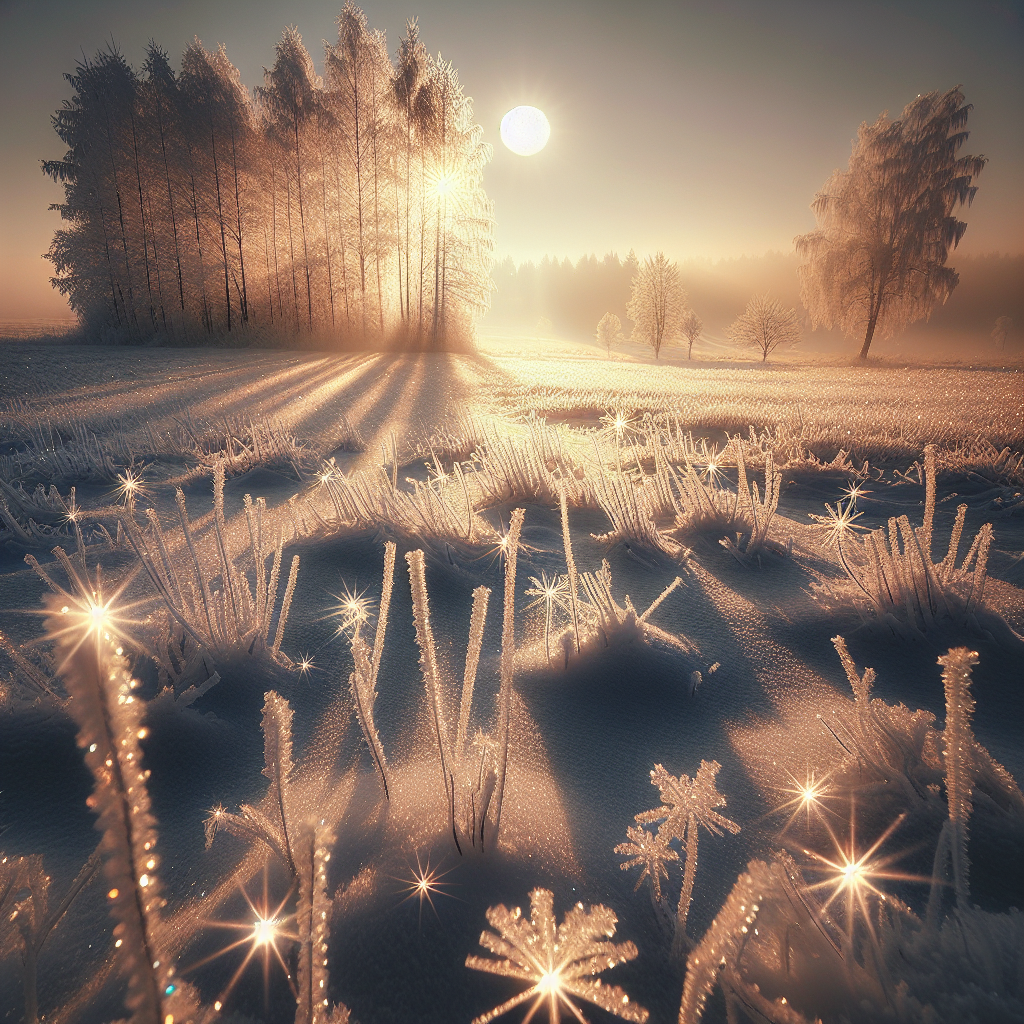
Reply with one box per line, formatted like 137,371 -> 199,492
795,87 -> 986,359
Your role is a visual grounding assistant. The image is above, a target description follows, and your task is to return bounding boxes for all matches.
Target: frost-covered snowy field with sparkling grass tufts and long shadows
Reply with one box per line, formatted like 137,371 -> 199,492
0,342 -> 1024,1024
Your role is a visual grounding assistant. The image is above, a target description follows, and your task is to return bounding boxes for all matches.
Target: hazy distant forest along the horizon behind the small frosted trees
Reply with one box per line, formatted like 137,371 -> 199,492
484,252 -> 1024,350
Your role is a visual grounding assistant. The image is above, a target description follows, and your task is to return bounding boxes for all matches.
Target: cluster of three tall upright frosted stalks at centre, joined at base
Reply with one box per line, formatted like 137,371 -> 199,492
406,509 -> 523,854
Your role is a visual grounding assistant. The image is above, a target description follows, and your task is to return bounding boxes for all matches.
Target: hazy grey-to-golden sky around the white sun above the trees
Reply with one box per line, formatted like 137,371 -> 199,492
0,0 -> 1024,321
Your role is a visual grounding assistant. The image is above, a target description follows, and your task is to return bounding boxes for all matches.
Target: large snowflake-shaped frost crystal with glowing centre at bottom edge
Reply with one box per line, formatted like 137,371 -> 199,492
466,889 -> 648,1024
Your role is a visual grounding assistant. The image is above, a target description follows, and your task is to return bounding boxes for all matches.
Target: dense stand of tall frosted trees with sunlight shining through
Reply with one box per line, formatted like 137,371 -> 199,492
43,3 -> 493,350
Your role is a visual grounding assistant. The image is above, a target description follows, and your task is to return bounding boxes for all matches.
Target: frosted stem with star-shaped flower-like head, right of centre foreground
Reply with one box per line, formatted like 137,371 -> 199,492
630,761 -> 739,948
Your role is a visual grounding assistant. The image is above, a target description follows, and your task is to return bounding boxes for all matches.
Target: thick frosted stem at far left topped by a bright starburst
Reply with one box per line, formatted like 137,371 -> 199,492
46,598 -> 197,1024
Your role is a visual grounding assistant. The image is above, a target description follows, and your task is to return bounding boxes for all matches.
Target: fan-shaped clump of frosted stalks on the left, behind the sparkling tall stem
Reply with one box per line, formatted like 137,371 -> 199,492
122,462 -> 299,678
